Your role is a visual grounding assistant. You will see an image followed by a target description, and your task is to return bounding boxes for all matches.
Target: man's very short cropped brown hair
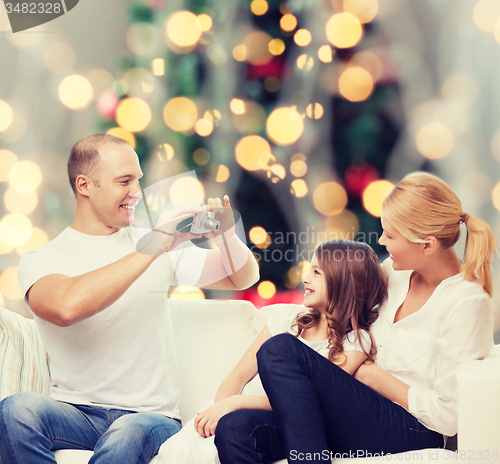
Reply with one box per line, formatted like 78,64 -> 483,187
68,134 -> 127,195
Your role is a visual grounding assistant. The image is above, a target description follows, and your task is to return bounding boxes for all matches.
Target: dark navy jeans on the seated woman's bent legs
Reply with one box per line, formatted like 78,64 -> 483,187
215,334 -> 444,464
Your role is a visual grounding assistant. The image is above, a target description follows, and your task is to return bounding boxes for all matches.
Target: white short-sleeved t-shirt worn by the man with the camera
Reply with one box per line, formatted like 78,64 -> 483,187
19,227 -> 206,418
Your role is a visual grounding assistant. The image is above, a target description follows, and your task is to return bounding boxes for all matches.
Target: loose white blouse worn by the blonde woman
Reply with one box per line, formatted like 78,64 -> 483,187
370,259 -> 493,436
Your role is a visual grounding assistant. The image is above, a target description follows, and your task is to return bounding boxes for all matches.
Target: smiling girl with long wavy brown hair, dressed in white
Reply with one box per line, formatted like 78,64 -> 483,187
158,240 -> 387,464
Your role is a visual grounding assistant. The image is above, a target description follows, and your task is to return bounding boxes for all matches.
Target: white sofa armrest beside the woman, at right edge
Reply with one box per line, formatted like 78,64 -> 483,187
458,346 -> 500,462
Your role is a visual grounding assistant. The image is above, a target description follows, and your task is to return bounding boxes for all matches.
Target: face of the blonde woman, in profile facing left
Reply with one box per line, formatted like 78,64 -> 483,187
378,214 -> 421,271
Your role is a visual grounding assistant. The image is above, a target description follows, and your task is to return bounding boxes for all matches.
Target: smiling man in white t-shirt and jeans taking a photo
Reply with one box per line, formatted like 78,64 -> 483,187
0,135 -> 258,464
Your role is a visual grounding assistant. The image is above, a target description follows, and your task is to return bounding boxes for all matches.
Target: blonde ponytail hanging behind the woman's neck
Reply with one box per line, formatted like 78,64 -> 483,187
462,214 -> 496,296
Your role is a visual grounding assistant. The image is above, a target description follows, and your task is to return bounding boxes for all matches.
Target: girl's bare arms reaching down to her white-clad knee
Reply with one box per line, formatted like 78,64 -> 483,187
194,325 -> 271,437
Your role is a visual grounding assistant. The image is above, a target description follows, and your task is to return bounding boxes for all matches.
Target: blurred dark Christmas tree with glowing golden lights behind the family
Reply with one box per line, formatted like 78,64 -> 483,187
94,0 -> 402,302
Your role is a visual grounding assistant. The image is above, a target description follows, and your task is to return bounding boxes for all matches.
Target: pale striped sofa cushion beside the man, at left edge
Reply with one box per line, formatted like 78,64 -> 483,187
0,307 -> 50,400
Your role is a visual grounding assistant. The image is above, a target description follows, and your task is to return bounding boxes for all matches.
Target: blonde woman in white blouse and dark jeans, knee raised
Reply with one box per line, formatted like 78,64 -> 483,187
215,173 -> 494,464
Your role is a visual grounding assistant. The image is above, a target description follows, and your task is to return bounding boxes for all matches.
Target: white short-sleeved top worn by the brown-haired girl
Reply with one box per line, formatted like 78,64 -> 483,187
242,304 -> 372,395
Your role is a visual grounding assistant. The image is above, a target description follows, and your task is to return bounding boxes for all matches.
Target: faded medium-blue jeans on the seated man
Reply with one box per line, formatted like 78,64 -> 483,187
0,393 -> 181,464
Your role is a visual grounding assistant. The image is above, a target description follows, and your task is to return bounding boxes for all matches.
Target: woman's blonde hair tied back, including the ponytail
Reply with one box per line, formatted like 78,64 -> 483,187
382,172 -> 496,295
